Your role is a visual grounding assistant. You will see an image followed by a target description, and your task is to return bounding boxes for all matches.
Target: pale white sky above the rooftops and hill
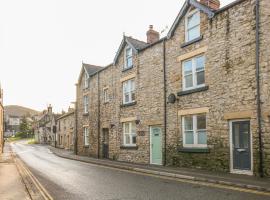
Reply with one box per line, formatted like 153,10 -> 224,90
0,0 -> 233,112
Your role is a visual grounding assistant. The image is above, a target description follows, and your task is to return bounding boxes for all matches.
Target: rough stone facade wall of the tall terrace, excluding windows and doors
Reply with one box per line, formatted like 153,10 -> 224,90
77,0 -> 270,174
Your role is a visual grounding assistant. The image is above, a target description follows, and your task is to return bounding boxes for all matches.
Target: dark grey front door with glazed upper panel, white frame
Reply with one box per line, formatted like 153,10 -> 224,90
232,121 -> 251,170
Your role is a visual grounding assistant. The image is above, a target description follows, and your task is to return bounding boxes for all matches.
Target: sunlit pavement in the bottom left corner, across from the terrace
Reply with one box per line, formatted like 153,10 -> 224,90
0,145 -> 30,200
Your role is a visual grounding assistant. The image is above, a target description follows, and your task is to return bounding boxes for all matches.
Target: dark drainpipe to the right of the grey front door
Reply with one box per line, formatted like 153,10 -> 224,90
255,0 -> 264,177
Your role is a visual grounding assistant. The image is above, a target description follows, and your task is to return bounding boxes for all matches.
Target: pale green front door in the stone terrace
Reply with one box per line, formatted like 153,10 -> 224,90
150,126 -> 162,165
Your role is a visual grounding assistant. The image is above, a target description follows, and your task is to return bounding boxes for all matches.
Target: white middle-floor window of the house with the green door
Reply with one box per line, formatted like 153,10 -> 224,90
123,79 -> 135,104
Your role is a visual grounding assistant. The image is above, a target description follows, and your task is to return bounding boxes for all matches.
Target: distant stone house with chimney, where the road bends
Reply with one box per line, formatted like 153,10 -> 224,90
33,105 -> 59,146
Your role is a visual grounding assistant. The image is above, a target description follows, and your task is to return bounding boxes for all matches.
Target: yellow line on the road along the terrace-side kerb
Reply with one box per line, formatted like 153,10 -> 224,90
81,162 -> 270,196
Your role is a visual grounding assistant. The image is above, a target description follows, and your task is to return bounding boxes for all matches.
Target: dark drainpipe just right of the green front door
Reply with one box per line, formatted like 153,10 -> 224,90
162,39 -> 167,166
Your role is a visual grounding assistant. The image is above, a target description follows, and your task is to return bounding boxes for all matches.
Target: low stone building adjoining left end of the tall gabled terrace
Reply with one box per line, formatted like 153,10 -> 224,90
56,108 -> 75,150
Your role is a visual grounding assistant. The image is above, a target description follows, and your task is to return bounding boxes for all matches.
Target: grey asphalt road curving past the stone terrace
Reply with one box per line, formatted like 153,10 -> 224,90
12,142 -> 270,200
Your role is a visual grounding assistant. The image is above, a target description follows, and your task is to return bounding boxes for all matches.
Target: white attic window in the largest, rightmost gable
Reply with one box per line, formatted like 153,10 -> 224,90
186,10 -> 200,42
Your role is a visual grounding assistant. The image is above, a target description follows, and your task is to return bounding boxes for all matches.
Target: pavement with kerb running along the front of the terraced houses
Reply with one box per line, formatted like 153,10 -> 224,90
49,146 -> 270,193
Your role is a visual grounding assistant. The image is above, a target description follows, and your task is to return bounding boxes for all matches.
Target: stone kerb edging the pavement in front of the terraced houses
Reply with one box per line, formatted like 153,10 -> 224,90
49,147 -> 270,192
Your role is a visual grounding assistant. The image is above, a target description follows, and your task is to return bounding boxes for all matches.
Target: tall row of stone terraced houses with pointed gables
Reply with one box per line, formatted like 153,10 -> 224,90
75,0 -> 270,176
